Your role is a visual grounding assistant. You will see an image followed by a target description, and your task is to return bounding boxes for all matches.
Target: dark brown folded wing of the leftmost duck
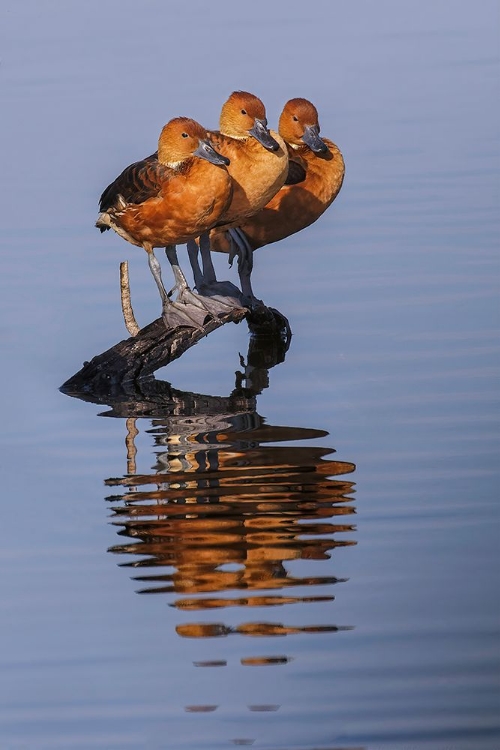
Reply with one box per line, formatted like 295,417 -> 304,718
99,154 -> 171,212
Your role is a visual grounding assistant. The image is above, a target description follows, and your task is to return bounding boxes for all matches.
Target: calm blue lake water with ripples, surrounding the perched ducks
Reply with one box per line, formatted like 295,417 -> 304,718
0,0 -> 500,750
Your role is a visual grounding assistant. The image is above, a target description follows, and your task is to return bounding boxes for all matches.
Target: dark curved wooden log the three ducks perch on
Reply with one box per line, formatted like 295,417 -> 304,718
61,305 -> 291,400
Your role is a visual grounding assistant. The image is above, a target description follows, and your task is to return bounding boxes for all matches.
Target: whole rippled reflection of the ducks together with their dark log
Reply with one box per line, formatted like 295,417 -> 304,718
98,336 -> 356,638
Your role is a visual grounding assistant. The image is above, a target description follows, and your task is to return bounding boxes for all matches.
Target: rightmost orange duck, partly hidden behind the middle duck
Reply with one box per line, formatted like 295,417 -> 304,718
210,98 -> 345,297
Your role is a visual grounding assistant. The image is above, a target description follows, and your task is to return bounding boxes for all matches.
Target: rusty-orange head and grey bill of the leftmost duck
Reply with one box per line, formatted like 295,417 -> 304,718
158,117 -> 229,169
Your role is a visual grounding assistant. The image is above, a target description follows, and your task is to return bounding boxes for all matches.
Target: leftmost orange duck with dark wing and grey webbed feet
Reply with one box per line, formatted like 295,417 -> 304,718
96,117 -> 233,328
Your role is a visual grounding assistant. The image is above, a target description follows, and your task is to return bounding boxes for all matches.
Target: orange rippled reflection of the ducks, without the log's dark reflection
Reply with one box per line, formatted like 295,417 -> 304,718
107,418 -> 354,616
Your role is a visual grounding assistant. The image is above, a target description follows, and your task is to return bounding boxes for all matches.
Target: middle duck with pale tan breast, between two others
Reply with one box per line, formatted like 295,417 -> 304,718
188,91 -> 288,302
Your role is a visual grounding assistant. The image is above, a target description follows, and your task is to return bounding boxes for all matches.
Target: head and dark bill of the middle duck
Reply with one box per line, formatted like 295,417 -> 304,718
220,91 -> 279,151
